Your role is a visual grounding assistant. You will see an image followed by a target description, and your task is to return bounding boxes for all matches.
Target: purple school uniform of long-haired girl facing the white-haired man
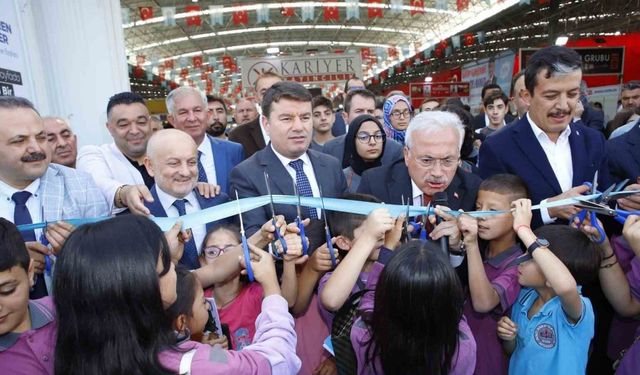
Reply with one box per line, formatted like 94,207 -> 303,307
351,258 -> 476,375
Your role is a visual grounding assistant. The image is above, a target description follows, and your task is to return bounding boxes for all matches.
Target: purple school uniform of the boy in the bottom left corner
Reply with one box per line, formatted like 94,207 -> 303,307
0,297 -> 56,375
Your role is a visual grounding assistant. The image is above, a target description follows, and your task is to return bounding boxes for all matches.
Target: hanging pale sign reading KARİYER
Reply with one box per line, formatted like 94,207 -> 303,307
240,53 -> 362,87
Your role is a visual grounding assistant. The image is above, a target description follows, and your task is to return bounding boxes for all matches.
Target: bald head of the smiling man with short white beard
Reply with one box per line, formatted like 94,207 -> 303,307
144,129 -> 198,199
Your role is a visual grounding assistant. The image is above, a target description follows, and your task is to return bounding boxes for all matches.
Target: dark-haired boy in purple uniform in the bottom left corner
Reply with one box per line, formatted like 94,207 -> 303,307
0,218 -> 56,374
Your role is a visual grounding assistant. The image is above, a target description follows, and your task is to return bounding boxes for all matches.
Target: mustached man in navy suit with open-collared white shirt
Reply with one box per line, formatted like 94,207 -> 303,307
478,46 -> 609,226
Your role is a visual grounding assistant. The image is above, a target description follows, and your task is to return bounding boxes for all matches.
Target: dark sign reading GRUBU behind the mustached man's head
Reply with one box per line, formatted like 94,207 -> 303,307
520,47 -> 624,76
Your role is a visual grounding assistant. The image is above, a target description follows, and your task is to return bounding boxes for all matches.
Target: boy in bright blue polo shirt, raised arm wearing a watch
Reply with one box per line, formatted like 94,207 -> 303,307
497,199 -> 602,375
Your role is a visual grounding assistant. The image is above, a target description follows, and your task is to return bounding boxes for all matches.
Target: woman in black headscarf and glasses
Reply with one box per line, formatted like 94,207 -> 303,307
342,115 -> 387,193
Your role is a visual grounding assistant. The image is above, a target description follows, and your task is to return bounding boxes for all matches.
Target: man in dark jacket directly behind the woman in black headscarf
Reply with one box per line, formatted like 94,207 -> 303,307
322,89 -> 402,168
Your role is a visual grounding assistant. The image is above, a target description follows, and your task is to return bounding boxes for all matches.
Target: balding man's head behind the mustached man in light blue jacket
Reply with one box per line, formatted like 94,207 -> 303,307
42,116 -> 78,168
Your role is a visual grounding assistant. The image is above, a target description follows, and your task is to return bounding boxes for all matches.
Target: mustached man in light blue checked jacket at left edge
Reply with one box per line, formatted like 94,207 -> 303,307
0,96 -> 109,298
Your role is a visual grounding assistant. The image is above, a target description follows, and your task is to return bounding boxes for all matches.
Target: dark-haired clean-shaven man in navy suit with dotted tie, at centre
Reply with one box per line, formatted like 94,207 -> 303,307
230,82 -> 347,235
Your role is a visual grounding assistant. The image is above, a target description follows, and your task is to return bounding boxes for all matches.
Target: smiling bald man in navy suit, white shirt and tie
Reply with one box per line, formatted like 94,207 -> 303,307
144,129 -> 229,269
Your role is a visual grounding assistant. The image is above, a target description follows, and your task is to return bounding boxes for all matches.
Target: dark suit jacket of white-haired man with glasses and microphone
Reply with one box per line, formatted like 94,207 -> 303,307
358,158 -> 481,211
